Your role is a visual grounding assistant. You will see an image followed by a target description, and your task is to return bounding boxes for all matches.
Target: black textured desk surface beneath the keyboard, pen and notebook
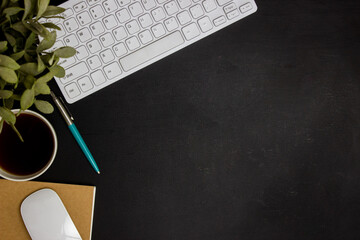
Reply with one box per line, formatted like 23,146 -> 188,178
38,0 -> 360,240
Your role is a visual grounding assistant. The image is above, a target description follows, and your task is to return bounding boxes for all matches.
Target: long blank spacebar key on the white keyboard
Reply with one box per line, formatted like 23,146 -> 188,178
119,31 -> 184,71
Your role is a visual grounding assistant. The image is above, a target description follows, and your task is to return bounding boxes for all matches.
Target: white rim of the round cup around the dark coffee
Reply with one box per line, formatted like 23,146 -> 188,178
0,109 -> 58,181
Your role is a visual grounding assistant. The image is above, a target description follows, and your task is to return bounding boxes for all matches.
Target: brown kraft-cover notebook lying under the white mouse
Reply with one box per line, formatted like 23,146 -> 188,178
0,179 -> 96,240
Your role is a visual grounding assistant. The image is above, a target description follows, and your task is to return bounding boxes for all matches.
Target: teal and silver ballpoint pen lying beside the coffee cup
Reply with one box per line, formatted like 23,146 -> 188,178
50,92 -> 100,174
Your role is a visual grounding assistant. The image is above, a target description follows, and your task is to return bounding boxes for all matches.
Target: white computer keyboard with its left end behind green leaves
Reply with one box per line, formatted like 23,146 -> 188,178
51,0 -> 257,103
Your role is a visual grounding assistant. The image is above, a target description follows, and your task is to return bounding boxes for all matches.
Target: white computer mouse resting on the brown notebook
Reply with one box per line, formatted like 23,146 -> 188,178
20,188 -> 81,240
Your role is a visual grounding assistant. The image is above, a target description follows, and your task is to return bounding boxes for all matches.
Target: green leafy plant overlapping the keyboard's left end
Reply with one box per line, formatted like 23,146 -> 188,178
0,0 -> 76,140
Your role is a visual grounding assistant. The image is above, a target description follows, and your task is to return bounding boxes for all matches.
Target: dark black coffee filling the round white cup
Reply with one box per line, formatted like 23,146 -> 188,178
0,113 -> 55,175
